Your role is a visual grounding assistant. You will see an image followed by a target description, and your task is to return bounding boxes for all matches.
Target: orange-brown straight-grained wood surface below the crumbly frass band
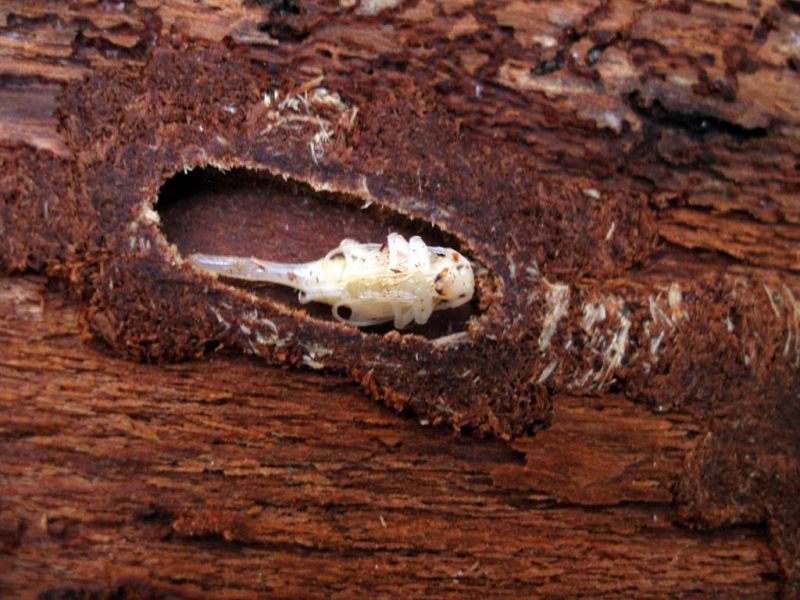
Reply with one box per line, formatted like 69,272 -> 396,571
0,277 -> 778,598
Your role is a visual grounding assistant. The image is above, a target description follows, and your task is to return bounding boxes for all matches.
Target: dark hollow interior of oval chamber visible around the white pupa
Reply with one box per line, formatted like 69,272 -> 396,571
156,167 -> 477,338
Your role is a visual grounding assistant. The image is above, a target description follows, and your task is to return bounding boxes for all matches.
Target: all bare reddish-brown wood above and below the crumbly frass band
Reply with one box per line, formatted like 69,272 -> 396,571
0,0 -> 800,598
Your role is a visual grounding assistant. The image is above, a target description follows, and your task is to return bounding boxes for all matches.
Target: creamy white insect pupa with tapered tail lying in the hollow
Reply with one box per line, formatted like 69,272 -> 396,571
189,233 -> 475,329
